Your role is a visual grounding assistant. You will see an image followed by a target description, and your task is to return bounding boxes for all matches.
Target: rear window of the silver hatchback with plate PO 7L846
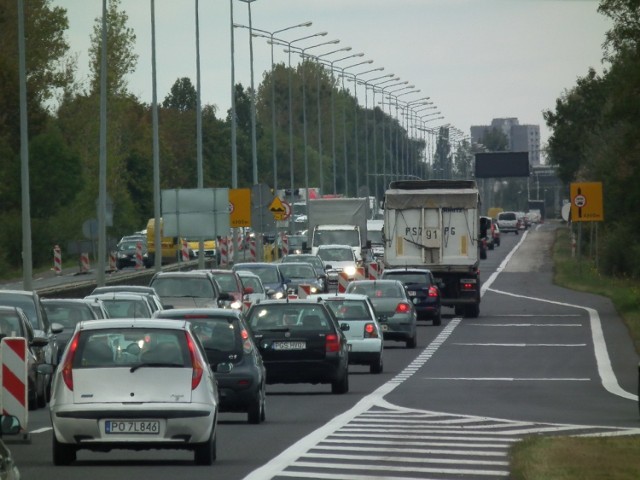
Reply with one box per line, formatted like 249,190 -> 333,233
73,328 -> 191,368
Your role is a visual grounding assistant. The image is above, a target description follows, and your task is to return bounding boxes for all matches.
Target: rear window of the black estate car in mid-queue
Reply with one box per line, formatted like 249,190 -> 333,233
249,303 -> 333,332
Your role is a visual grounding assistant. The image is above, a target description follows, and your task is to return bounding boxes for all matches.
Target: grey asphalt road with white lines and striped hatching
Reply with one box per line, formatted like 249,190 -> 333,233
9,224 -> 640,480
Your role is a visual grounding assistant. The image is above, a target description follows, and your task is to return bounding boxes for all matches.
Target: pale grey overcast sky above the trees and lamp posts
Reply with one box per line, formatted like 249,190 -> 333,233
52,0 -> 611,163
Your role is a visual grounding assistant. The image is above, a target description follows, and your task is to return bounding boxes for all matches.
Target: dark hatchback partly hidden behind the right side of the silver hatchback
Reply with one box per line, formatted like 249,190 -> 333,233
155,308 -> 266,423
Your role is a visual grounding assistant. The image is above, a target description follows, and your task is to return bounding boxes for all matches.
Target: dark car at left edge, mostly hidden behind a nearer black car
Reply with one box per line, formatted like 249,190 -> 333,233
0,290 -> 64,398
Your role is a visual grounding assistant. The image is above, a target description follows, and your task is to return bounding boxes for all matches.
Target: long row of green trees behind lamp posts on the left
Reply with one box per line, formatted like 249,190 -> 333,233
0,0 -> 470,269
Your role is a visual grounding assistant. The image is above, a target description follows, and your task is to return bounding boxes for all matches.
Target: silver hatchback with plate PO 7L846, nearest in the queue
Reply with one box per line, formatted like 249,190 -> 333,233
49,318 -> 219,465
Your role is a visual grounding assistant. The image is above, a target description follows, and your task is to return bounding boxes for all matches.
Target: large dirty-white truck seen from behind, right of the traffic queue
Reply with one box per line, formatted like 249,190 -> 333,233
384,180 -> 484,317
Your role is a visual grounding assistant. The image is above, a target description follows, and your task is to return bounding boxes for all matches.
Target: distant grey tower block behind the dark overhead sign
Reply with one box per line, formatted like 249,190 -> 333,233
471,118 -> 540,166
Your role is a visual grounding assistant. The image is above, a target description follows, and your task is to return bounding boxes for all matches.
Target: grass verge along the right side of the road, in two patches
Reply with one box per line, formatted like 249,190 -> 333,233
509,228 -> 640,480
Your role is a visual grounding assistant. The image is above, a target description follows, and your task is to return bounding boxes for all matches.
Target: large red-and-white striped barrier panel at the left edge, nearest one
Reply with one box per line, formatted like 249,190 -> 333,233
0,337 -> 29,431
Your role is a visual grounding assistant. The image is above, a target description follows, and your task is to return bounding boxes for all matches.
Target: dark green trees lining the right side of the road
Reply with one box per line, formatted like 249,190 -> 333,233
544,0 -> 640,278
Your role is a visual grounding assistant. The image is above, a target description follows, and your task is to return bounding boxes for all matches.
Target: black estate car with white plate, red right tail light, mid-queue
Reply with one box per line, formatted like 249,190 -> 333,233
247,300 -> 349,393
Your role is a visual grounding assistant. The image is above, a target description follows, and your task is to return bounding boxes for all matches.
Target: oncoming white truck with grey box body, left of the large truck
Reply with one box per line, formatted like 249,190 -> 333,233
307,197 -> 369,262
